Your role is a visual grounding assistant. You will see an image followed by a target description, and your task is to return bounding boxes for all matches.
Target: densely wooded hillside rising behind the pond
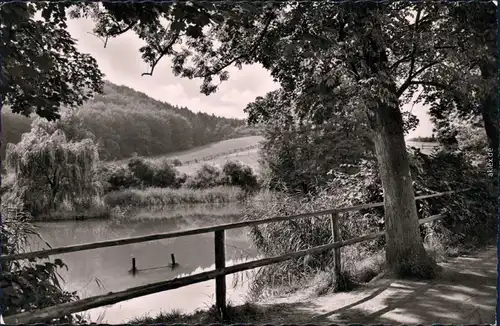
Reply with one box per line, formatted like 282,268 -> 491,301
0,82 -> 258,160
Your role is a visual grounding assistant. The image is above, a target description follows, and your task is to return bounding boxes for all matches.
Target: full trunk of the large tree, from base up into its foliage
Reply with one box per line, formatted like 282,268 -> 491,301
363,15 -> 437,278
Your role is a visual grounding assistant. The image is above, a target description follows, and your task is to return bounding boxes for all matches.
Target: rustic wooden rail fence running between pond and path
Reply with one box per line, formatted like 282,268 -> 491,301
0,189 -> 468,324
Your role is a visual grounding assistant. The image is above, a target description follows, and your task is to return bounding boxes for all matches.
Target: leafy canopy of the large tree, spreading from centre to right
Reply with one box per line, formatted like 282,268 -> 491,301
67,1 -> 496,130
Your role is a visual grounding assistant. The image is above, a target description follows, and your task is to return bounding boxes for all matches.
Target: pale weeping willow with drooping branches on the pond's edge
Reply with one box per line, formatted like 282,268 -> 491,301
6,120 -> 101,215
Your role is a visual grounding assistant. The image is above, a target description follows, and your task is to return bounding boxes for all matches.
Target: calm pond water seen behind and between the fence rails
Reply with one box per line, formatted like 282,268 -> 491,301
30,211 -> 256,323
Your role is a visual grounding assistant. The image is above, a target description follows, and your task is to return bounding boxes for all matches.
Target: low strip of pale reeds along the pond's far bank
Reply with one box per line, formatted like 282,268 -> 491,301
104,186 -> 247,207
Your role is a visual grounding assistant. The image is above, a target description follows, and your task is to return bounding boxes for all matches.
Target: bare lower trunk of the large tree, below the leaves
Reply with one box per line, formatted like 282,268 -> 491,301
373,103 -> 436,278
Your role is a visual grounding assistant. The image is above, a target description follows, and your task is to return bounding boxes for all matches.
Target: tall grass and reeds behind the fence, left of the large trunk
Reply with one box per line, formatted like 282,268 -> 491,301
245,162 -> 384,299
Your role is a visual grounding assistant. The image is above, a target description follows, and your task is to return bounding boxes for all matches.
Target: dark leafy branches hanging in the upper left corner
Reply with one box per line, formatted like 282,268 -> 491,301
0,1 -> 103,120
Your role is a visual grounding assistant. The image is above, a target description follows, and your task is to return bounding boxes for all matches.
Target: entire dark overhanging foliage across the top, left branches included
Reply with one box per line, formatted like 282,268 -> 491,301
0,1 -> 496,130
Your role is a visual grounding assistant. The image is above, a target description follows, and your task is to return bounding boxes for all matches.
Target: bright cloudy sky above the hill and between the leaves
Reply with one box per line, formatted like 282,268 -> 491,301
68,19 -> 433,138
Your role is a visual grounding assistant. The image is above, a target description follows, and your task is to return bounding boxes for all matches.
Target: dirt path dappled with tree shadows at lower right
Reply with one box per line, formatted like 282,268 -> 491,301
258,247 -> 497,324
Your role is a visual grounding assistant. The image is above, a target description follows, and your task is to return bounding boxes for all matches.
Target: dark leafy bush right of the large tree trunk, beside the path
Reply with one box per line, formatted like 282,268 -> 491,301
410,151 -> 498,247
